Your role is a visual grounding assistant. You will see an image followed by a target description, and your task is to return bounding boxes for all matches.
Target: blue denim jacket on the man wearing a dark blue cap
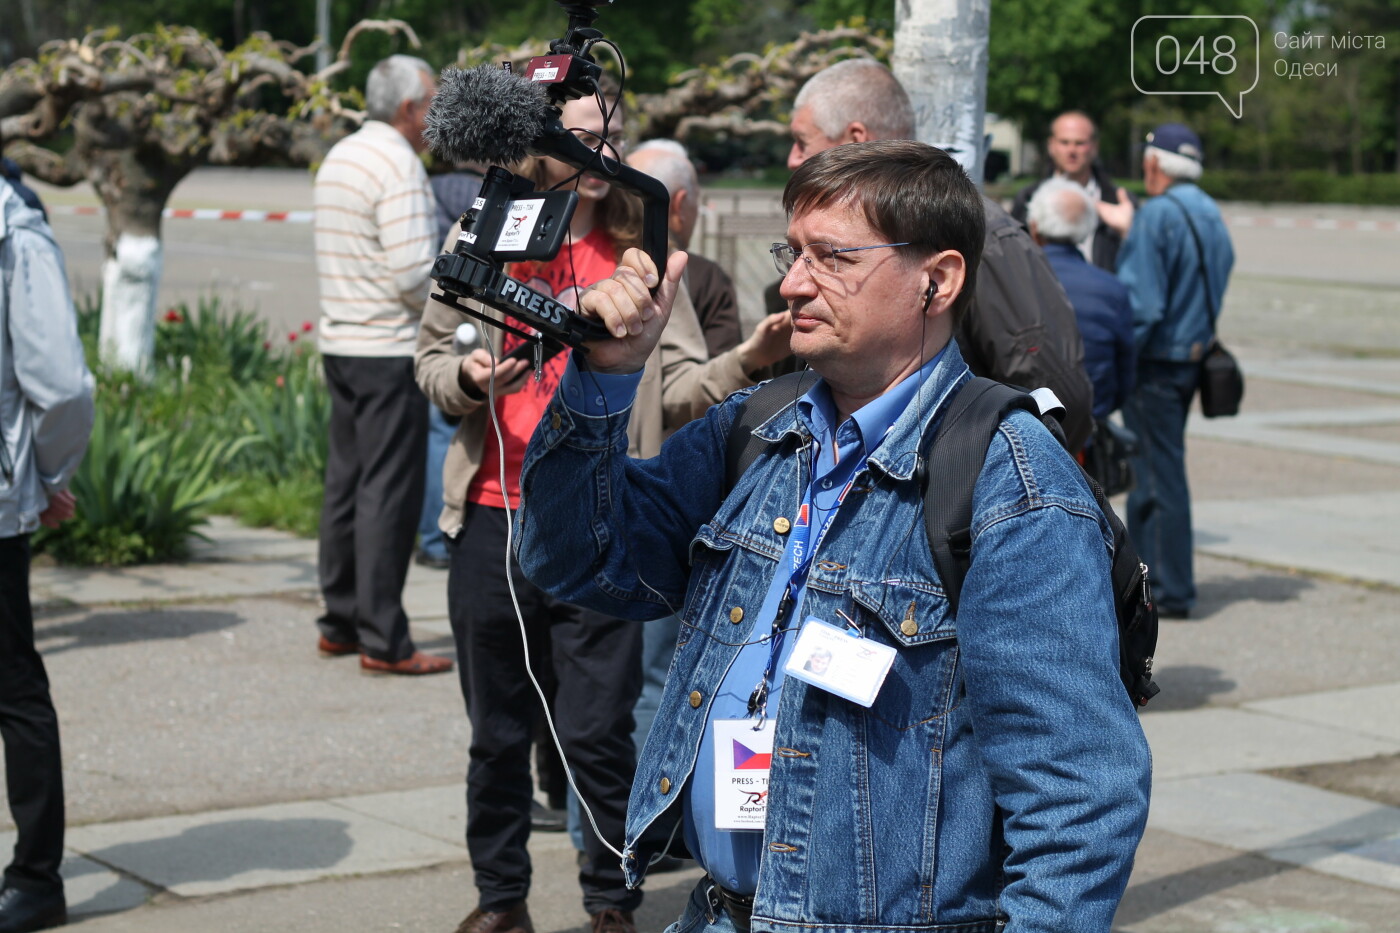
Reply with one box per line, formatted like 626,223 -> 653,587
1119,182 -> 1235,363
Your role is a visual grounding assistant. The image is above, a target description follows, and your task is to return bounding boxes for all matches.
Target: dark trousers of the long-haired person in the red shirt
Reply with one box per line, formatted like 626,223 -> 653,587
448,506 -> 641,913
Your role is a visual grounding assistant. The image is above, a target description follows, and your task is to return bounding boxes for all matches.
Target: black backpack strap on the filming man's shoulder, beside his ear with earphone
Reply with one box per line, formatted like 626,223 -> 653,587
920,377 -> 1040,616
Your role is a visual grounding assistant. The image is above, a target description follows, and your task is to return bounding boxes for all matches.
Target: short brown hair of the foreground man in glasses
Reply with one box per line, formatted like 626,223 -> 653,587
783,139 -> 987,328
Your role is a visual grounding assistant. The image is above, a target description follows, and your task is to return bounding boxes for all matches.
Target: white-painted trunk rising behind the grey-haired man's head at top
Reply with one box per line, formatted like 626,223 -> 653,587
890,0 -> 991,185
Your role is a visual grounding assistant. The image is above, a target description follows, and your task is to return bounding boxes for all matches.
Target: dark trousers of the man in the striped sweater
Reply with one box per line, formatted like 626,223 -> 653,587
316,356 -> 428,661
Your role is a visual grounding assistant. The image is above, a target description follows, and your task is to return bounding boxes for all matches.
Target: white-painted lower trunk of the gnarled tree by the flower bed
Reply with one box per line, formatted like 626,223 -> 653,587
98,234 -> 161,373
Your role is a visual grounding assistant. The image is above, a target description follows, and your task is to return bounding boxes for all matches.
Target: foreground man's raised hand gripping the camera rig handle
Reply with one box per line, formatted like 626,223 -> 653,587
578,248 -> 687,374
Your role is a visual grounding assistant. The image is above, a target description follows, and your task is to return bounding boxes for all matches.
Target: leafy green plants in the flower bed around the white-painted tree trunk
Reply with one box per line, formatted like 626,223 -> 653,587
35,297 -> 330,566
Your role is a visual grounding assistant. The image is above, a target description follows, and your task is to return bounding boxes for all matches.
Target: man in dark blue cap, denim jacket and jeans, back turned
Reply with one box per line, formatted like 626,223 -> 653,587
1099,123 -> 1235,619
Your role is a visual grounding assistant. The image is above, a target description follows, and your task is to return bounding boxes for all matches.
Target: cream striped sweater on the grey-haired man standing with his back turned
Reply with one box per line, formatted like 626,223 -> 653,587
314,120 -> 438,356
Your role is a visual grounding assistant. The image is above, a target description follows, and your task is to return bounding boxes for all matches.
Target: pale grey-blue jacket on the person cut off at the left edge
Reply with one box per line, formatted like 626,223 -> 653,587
0,184 -> 92,538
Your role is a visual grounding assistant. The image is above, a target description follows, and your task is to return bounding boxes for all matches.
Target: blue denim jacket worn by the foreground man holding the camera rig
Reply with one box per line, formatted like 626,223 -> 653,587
517,346 -> 1151,933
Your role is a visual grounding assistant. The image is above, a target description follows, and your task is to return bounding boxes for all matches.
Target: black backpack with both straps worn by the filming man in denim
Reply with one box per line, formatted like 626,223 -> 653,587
725,373 -> 1161,706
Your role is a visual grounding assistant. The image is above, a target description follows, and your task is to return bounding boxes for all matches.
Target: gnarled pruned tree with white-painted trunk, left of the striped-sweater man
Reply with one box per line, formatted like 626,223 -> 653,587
0,21 -> 417,371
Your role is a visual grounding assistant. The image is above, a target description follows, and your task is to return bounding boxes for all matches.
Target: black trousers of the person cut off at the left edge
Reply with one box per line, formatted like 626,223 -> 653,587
0,535 -> 63,891
